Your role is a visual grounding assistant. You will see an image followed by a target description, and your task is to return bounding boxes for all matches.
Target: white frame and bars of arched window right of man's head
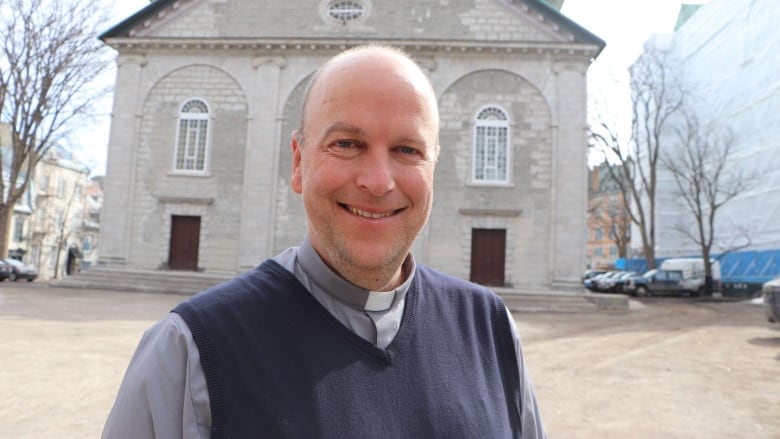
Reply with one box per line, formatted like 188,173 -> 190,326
471,104 -> 512,186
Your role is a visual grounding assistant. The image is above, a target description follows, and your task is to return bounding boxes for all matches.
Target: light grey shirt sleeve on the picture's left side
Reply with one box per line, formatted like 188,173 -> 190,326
102,313 -> 211,439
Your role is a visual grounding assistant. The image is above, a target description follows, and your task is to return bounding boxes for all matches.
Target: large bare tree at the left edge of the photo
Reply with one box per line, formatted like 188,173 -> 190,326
0,0 -> 109,256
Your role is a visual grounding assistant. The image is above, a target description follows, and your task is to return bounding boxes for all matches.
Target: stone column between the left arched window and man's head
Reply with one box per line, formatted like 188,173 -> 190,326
239,56 -> 286,269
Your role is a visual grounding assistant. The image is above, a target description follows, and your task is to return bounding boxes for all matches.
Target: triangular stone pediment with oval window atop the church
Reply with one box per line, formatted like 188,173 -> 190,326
101,0 -> 604,51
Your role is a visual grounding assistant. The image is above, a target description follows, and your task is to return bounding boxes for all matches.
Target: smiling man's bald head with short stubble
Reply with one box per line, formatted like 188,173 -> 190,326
291,46 -> 439,290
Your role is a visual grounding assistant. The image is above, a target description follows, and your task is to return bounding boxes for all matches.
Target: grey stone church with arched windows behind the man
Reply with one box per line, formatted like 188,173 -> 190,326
99,0 -> 604,289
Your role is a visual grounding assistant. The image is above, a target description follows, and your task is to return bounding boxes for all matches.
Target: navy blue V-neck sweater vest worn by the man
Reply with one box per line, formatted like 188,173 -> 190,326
174,261 -> 521,439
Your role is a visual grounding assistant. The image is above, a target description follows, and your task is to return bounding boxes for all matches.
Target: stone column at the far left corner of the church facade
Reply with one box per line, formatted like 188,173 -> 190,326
98,54 -> 146,266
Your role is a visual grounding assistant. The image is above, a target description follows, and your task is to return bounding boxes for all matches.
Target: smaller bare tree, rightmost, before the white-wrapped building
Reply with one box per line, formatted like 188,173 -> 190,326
661,112 -> 756,295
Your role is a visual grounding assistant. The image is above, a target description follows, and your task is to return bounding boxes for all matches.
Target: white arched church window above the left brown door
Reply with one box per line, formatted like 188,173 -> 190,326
173,99 -> 209,173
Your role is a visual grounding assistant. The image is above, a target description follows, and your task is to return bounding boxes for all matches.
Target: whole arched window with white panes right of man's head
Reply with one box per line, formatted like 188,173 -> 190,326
473,106 -> 509,183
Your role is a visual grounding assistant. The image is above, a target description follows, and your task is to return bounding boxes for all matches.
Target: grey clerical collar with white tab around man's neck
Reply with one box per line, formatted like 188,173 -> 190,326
296,237 -> 415,311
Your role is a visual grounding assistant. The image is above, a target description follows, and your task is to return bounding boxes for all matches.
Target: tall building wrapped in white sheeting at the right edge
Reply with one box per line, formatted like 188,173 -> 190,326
640,0 -> 780,264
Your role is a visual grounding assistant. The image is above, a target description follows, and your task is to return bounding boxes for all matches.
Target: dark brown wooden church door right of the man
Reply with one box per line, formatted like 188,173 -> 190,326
471,229 -> 506,287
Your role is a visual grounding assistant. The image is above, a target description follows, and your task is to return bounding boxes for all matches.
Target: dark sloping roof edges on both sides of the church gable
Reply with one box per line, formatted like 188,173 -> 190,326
99,0 -> 606,55
